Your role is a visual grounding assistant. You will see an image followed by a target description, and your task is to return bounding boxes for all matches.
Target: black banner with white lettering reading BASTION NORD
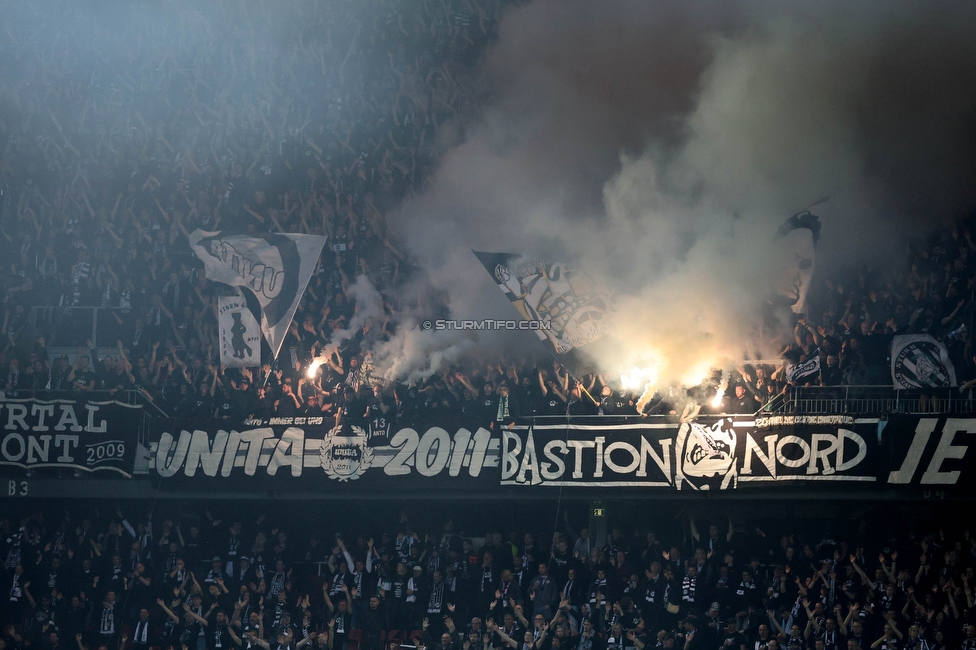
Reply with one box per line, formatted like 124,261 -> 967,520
501,416 -> 880,491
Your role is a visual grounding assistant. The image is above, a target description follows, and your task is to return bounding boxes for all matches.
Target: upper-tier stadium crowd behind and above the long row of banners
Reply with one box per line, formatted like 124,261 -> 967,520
0,0 -> 976,422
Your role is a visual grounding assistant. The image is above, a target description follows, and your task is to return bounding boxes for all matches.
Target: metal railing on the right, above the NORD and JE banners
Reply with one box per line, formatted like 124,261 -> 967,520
763,386 -> 976,415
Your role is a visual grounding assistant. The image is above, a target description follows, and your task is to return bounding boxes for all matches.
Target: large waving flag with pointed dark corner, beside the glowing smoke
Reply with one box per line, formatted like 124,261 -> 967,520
472,251 -> 614,354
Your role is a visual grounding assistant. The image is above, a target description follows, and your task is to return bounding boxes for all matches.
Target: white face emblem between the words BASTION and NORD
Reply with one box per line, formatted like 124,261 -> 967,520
675,419 -> 737,490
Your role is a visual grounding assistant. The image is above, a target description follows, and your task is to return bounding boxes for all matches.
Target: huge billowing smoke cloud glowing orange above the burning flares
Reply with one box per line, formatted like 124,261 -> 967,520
384,1 -> 976,382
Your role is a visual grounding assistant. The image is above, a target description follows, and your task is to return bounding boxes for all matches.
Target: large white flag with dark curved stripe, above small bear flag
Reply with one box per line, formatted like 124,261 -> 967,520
190,230 -> 325,356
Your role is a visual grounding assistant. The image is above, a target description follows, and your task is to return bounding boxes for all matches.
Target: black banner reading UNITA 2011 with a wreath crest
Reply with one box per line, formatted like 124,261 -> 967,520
150,416 -> 499,491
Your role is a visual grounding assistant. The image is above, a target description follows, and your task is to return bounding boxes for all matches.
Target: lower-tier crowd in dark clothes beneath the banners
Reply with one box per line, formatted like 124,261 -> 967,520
0,504 -> 976,650
